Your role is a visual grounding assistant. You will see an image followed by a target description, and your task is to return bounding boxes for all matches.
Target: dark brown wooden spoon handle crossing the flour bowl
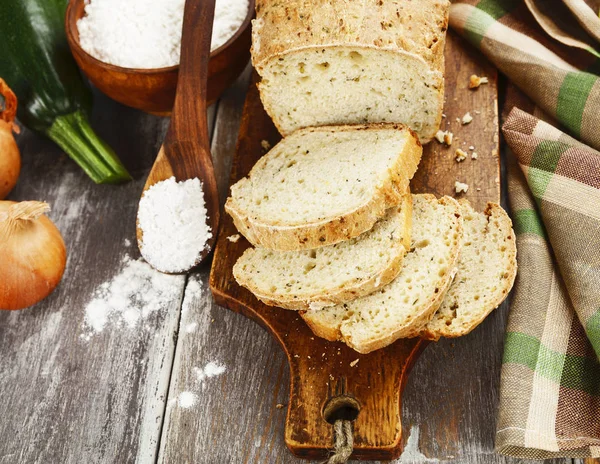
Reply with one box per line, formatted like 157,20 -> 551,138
165,0 -> 215,150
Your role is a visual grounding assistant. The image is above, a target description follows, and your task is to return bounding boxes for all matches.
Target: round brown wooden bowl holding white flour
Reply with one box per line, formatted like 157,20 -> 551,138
65,0 -> 254,115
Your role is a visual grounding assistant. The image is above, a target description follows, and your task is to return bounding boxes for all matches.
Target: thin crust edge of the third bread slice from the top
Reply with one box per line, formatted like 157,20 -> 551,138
301,194 -> 463,354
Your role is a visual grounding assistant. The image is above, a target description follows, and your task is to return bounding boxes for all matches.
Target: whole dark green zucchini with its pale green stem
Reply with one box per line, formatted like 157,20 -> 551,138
0,0 -> 131,183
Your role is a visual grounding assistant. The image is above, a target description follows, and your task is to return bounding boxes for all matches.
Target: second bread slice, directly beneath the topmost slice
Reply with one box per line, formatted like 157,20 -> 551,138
233,194 -> 412,310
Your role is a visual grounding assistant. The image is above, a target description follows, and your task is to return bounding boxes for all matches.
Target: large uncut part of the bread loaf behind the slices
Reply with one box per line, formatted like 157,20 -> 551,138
252,0 -> 450,143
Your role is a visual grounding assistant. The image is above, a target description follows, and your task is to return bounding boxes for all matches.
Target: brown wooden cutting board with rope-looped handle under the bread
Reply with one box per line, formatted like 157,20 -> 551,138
210,33 -> 500,460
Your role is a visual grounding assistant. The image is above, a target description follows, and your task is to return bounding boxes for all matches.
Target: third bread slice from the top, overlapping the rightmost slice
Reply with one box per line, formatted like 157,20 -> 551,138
302,195 -> 462,353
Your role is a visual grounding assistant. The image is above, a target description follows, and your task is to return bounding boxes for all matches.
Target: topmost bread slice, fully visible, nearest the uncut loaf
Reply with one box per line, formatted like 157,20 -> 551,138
225,124 -> 422,251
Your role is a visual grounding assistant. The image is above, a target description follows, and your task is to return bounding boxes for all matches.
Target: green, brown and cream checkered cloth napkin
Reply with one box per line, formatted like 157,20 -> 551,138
450,0 -> 600,459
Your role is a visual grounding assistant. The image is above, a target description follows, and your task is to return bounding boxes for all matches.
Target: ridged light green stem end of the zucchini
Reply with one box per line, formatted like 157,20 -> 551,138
46,110 -> 131,184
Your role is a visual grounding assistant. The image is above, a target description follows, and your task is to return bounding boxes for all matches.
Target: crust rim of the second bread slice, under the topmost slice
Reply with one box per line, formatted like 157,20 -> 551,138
233,193 -> 412,311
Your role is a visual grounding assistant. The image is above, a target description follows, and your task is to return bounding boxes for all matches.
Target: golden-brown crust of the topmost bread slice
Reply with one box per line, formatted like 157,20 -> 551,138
225,123 -> 422,251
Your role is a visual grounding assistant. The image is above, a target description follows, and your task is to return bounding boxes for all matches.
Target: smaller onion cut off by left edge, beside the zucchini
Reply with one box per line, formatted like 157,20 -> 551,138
0,79 -> 21,200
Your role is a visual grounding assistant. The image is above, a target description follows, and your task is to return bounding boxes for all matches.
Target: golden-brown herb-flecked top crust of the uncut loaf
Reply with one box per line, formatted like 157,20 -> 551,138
251,0 -> 450,73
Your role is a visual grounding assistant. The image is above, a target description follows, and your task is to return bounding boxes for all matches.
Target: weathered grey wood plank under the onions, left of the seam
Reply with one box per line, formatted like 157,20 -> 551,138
0,92 -> 214,464
